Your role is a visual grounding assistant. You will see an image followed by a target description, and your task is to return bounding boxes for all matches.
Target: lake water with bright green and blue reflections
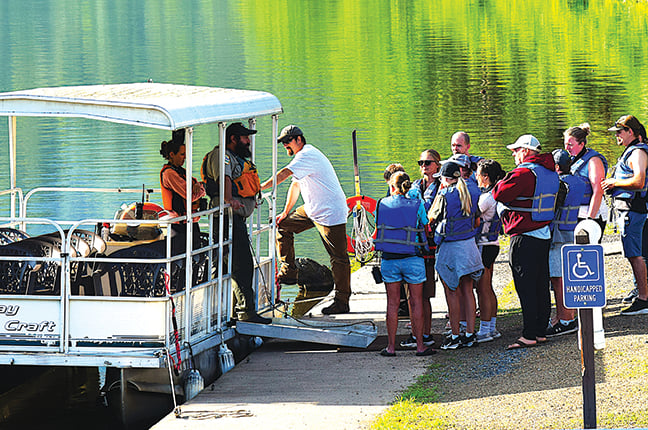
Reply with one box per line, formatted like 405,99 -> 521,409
0,0 -> 648,426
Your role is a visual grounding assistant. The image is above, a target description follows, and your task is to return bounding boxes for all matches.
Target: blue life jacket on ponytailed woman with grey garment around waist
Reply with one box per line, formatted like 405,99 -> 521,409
434,185 -> 479,245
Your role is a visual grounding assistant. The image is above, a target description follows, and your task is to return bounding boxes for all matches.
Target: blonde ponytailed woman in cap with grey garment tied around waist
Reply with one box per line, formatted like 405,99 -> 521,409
428,162 -> 484,349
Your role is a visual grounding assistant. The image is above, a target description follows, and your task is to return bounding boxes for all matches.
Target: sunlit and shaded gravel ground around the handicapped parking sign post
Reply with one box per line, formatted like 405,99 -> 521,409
410,237 -> 648,429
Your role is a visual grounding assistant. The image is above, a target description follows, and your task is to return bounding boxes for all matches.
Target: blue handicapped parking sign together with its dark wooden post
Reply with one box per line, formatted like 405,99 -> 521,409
561,244 -> 605,429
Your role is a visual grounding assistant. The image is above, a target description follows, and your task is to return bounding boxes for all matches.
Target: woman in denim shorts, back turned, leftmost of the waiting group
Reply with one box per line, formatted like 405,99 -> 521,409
374,172 -> 436,357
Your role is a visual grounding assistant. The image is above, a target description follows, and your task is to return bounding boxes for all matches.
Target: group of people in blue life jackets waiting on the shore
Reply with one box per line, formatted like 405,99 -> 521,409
374,115 -> 648,356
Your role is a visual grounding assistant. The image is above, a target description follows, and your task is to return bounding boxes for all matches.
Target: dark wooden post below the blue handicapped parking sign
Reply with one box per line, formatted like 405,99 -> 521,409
578,308 -> 596,429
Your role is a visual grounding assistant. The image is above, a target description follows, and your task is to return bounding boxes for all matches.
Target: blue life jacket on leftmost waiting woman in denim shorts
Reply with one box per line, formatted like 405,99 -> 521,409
374,196 -> 423,255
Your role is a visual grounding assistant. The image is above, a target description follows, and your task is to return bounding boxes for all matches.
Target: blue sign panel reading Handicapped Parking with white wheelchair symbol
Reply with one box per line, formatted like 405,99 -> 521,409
561,245 -> 606,309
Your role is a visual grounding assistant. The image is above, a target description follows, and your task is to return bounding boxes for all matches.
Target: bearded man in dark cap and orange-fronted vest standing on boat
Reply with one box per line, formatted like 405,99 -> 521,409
201,122 -> 272,324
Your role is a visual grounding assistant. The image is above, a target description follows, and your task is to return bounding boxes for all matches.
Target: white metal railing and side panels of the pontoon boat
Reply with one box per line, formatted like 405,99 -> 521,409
0,187 -> 274,367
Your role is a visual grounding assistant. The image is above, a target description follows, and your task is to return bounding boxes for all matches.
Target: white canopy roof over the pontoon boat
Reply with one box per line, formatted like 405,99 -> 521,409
0,83 -> 283,130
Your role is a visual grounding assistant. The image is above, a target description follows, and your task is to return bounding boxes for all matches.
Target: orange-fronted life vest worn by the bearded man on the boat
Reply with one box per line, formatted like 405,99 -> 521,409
200,148 -> 261,198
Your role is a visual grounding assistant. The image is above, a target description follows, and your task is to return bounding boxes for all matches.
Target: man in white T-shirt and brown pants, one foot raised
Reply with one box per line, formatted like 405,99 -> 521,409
261,125 -> 351,315
